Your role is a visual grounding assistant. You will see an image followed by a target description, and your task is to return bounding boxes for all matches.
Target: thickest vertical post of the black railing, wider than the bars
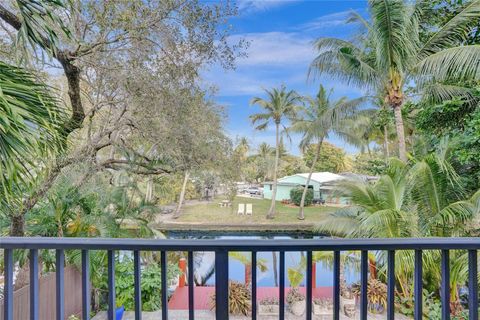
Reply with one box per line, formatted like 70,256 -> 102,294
215,250 -> 228,320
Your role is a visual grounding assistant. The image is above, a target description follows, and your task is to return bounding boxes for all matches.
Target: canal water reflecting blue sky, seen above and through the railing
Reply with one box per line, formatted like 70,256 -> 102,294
166,231 -> 360,287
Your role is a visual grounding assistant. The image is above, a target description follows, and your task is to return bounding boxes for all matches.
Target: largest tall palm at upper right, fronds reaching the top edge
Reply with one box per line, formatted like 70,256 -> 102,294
311,0 -> 480,161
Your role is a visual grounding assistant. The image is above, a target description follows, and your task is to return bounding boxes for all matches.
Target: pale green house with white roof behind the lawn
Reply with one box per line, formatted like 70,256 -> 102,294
263,172 -> 346,204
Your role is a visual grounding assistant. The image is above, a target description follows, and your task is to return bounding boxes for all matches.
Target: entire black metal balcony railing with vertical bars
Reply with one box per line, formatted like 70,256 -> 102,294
0,238 -> 480,320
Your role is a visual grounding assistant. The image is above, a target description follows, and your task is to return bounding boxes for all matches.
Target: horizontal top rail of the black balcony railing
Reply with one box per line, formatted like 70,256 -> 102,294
0,237 -> 480,251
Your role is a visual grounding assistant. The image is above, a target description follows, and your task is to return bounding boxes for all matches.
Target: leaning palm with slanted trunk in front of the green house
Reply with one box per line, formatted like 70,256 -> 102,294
290,85 -> 365,220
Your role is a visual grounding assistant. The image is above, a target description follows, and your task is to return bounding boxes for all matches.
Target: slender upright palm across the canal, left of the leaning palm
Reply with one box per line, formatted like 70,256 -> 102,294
250,86 -> 301,219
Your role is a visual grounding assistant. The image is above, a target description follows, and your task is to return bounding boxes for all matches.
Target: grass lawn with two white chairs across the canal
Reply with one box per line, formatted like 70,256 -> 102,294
175,197 -> 337,225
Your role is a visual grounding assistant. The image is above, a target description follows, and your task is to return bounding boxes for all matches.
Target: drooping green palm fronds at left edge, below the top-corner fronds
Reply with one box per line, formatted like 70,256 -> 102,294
0,62 -> 63,236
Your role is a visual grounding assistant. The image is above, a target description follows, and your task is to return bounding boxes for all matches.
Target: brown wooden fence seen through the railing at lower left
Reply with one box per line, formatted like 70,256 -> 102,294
0,266 -> 82,320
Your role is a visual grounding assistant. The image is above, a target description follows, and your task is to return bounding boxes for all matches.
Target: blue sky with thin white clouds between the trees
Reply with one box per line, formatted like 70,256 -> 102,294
204,0 -> 366,154
